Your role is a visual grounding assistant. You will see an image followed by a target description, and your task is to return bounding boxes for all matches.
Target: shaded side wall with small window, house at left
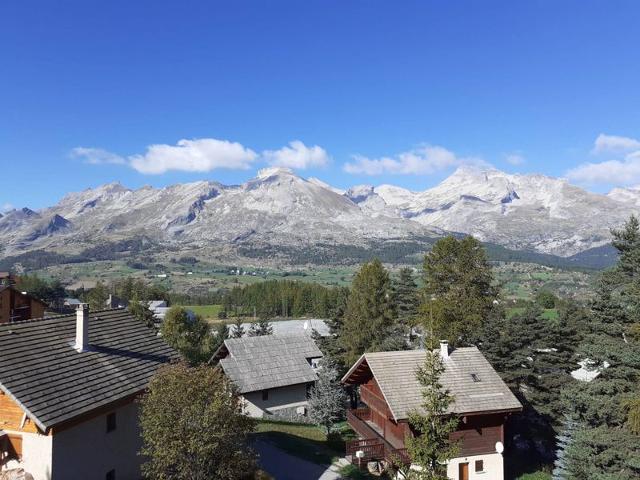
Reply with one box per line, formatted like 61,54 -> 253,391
51,403 -> 142,480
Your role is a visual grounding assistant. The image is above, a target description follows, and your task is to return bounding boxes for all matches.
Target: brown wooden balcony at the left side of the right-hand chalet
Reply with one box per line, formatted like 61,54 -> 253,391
346,408 -> 411,465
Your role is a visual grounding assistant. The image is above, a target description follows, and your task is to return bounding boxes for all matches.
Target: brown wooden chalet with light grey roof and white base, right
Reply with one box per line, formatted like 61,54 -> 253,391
342,342 -> 522,480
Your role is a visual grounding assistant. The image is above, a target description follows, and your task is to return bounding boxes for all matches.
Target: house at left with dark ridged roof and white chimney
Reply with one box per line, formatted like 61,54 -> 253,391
0,305 -> 178,480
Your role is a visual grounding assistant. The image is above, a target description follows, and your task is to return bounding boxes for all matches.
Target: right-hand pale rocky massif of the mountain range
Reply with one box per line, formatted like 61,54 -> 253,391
356,167 -> 638,256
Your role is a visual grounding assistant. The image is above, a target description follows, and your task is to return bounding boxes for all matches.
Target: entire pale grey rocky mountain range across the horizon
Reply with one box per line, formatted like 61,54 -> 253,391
0,167 -> 640,268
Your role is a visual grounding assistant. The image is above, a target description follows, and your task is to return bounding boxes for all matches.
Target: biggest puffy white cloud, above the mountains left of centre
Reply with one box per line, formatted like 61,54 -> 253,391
129,138 -> 258,175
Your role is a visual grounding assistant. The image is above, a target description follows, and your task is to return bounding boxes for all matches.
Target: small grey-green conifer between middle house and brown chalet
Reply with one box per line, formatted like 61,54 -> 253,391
309,357 -> 346,435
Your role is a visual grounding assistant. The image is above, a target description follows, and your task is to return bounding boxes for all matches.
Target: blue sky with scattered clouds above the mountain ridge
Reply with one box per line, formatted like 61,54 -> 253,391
0,0 -> 640,208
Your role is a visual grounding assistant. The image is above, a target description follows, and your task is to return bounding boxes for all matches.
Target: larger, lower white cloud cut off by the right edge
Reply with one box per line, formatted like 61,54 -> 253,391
566,150 -> 640,186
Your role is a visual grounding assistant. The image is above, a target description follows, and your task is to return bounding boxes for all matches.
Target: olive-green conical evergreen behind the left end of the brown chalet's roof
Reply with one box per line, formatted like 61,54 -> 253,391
340,259 -> 396,365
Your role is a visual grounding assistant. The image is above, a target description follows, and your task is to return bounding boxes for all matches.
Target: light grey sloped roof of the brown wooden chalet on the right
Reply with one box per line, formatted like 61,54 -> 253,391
342,347 -> 522,421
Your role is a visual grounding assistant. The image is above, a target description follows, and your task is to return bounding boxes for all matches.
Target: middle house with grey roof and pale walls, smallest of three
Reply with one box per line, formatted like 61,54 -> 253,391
212,335 -> 322,421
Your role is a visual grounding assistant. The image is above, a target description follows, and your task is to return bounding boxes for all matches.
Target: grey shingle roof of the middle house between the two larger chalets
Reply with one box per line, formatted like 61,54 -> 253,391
216,335 -> 322,393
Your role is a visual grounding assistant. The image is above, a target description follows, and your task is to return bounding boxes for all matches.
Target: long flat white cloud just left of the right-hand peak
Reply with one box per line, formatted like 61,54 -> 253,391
344,145 -> 486,175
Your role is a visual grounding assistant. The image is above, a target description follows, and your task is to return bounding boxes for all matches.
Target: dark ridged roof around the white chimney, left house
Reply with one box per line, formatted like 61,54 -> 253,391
0,310 -> 179,430
